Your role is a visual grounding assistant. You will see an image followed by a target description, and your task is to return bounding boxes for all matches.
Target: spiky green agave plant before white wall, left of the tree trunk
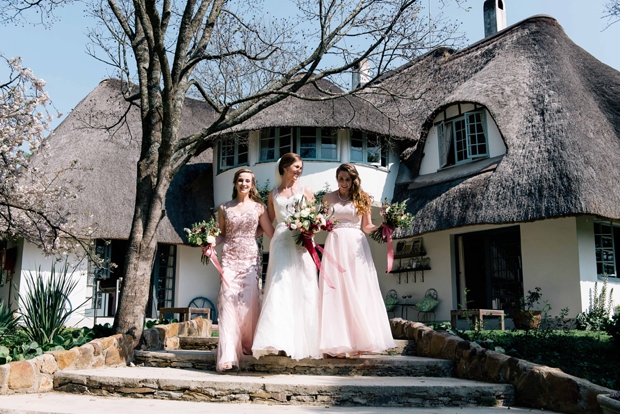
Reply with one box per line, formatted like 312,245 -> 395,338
19,262 -> 78,345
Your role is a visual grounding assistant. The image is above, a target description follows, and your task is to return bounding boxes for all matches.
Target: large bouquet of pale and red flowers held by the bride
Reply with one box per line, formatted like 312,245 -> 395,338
284,197 -> 337,246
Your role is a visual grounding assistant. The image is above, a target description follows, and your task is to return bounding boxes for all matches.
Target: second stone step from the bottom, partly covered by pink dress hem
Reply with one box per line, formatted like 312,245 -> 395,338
134,350 -> 454,377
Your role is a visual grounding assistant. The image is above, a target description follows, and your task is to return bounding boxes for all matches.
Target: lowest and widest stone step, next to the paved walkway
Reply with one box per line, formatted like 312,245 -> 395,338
54,367 -> 514,407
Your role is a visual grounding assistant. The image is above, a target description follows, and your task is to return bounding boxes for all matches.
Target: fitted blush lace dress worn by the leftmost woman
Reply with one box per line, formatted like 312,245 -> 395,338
216,203 -> 265,371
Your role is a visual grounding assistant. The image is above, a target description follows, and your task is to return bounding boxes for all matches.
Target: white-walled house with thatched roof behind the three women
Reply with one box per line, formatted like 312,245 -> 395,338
0,1 -> 620,324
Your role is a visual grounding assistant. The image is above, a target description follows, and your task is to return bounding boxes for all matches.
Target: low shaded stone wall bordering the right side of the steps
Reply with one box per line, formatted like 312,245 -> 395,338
390,318 -> 613,414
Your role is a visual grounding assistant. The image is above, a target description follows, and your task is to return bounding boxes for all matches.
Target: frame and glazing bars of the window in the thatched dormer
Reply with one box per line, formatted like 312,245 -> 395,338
436,109 -> 490,170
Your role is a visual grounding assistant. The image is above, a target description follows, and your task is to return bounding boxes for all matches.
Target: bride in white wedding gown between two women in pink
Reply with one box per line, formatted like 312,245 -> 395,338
252,153 -> 322,360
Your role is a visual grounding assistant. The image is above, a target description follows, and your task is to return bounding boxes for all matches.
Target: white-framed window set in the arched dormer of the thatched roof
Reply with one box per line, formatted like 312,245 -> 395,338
437,111 -> 489,168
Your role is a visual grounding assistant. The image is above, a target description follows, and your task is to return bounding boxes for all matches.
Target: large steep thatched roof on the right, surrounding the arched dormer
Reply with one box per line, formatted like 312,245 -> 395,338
374,16 -> 620,236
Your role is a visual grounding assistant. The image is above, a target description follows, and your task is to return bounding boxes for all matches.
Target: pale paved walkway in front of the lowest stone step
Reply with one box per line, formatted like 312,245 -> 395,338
0,392 -> 552,414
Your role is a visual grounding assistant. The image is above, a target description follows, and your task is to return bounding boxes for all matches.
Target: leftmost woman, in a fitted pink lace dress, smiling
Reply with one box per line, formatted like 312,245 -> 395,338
216,169 -> 273,371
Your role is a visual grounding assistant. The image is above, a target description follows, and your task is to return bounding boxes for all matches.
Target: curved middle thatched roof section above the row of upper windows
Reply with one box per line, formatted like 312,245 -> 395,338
224,79 -> 408,137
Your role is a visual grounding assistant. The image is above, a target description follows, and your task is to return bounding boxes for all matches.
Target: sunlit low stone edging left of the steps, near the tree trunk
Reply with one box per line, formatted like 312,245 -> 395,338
0,317 -> 211,395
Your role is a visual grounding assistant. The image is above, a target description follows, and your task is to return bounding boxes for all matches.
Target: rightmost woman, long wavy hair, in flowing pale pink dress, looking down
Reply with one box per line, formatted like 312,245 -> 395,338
319,164 -> 396,357
